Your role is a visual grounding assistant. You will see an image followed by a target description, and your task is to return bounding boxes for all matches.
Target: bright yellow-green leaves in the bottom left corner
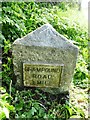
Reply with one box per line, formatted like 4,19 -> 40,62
0,87 -> 15,120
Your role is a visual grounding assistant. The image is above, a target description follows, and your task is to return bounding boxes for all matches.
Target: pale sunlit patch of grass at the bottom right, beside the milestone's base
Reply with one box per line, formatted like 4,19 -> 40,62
69,84 -> 89,118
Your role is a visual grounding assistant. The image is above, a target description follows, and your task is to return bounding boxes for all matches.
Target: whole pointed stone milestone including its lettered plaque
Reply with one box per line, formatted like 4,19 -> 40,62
12,24 -> 78,94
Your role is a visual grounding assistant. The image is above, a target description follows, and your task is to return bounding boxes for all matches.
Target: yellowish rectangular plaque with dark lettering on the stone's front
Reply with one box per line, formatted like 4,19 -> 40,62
23,63 -> 62,88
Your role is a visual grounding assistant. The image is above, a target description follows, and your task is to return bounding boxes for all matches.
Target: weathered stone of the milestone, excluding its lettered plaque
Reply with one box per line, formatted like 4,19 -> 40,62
13,24 -> 78,94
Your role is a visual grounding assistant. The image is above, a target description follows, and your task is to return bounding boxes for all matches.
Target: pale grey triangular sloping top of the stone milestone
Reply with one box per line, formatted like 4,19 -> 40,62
13,23 -> 77,49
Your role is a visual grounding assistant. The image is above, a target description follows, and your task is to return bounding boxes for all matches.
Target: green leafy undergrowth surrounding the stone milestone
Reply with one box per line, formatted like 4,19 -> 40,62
0,1 -> 90,120
